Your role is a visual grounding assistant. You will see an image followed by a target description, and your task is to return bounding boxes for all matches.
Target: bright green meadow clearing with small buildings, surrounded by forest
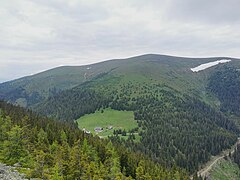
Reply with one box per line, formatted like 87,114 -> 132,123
76,109 -> 138,137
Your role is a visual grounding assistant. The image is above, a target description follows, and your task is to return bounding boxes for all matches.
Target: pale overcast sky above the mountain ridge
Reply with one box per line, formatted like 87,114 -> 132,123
0,0 -> 240,82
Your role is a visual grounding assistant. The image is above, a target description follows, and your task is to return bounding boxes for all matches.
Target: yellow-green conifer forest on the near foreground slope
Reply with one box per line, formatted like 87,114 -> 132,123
0,101 -> 187,179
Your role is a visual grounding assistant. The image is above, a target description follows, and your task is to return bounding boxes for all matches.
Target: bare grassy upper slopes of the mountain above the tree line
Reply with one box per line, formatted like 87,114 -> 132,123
0,54 -> 236,107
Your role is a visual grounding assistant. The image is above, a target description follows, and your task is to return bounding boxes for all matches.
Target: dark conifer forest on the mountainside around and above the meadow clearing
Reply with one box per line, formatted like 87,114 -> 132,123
36,76 -> 239,172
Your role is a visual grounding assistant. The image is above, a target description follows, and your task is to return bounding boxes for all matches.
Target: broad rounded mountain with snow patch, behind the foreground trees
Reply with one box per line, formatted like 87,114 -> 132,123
0,54 -> 240,176
